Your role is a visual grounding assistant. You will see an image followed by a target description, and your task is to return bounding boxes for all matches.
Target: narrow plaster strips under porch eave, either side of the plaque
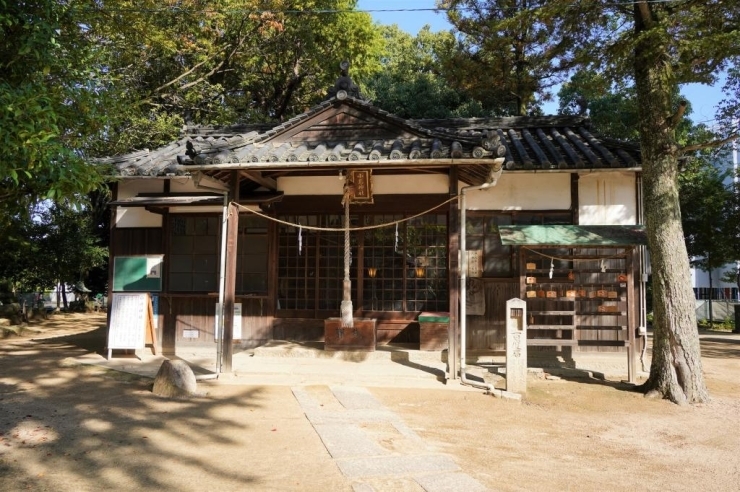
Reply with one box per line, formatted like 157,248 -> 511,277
277,174 -> 449,196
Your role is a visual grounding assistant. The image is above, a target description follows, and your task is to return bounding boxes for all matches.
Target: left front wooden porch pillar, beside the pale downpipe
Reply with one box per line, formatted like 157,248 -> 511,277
221,171 -> 239,373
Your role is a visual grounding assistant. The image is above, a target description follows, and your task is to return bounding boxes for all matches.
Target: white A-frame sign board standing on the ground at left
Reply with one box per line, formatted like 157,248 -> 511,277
106,292 -> 157,360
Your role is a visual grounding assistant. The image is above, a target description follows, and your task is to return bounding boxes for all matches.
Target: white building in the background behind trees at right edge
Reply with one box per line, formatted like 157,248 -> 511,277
691,138 -> 740,319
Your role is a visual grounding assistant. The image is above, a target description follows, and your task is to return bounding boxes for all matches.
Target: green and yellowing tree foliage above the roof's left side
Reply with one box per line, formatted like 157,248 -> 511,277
0,0 -> 382,216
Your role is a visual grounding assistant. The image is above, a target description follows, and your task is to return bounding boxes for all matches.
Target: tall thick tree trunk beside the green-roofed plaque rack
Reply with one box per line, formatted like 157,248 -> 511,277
635,2 -> 709,404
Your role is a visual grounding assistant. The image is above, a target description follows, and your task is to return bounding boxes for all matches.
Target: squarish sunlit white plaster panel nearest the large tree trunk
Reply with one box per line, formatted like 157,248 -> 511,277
578,172 -> 637,225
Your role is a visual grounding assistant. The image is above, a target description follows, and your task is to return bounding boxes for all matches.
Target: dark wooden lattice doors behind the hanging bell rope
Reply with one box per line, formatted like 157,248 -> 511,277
278,214 -> 449,312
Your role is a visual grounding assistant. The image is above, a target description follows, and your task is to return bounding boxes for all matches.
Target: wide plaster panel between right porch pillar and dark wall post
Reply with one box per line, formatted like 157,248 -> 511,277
460,171 -> 570,210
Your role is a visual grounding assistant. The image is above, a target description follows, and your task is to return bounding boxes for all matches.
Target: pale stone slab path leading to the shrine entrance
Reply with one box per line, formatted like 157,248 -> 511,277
292,386 -> 488,492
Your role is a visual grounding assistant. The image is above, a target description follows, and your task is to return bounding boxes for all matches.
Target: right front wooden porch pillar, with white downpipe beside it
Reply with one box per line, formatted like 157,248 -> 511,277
447,167 -> 460,379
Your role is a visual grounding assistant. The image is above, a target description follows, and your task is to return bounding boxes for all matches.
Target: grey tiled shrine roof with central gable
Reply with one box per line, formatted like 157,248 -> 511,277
98,94 -> 640,184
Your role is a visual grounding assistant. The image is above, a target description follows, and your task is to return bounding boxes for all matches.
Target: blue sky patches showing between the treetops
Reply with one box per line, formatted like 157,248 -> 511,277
357,0 -> 722,124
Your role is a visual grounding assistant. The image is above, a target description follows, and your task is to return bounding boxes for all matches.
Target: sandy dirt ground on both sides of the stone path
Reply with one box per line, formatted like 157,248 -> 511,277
0,314 -> 740,491
